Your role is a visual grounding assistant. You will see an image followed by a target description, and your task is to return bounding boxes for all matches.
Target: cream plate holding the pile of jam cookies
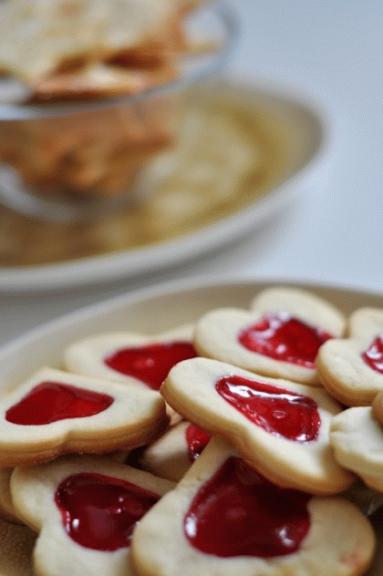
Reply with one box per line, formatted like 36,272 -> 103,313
0,280 -> 383,576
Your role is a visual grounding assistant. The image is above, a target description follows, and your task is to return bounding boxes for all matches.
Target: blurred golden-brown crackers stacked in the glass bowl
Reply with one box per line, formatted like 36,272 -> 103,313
0,0 -> 197,197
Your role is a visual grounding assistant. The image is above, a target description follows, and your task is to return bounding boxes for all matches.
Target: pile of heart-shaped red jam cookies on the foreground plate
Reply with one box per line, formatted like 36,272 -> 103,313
0,288 -> 383,576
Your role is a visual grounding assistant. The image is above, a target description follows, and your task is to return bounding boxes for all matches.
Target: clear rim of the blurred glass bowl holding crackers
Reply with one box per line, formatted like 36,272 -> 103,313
0,0 -> 239,122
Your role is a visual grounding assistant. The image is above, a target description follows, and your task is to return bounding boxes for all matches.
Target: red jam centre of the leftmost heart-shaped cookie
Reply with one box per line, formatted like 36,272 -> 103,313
5,381 -> 114,426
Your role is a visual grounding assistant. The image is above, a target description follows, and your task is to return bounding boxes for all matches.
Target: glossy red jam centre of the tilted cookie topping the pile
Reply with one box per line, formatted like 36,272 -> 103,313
215,376 -> 321,442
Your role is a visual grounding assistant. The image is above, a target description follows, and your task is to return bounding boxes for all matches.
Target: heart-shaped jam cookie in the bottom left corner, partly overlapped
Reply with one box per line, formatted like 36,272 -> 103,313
11,457 -> 173,576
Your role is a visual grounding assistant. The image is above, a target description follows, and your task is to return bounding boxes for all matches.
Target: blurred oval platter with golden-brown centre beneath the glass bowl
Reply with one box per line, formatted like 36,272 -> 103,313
0,79 -> 327,292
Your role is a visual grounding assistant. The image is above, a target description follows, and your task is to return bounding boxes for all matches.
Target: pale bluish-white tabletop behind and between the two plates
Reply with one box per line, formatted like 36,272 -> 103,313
0,0 -> 383,343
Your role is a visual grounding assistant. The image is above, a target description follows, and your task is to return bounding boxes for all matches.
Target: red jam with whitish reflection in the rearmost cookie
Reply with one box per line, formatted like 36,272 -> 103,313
238,312 -> 331,368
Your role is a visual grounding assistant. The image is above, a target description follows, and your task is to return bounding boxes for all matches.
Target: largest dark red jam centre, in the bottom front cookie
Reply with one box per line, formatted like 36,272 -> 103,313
184,457 -> 310,558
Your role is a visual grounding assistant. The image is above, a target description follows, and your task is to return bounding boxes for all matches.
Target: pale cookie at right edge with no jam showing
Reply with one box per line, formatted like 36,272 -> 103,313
330,406 -> 383,492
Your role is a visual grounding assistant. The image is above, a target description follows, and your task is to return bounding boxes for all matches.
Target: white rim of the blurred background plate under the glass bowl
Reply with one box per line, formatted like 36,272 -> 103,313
0,73 -> 331,293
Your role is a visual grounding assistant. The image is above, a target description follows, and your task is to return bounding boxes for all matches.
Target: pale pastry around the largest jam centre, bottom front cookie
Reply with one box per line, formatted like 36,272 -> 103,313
132,439 -> 375,576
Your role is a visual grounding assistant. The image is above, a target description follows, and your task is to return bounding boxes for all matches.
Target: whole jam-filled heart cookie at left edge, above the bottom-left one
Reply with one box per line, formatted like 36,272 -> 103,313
0,368 -> 168,467
